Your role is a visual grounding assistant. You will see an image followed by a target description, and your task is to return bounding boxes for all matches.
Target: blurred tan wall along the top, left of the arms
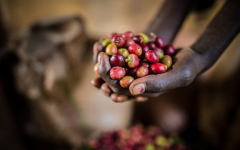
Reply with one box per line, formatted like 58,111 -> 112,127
0,0 -> 164,37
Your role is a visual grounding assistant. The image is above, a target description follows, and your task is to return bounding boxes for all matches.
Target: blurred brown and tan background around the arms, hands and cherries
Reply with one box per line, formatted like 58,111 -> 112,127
0,0 -> 240,150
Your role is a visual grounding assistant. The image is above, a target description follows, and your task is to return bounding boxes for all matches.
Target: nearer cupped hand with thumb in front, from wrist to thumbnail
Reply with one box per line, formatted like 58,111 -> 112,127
129,48 -> 202,95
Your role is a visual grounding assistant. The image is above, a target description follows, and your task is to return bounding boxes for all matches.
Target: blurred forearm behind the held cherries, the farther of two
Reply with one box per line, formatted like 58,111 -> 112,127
146,0 -> 192,43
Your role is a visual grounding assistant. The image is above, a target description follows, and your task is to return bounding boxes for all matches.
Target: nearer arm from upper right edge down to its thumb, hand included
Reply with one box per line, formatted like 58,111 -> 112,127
125,0 -> 240,95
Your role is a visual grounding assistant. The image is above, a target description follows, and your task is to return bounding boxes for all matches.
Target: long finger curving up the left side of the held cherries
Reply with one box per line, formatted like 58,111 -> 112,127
98,52 -> 130,95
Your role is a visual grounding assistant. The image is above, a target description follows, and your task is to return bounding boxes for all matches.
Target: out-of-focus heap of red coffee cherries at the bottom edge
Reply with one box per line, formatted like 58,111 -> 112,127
81,125 -> 186,150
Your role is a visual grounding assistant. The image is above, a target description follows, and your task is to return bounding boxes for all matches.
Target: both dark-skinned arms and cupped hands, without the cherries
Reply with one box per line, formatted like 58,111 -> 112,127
91,1 -> 240,102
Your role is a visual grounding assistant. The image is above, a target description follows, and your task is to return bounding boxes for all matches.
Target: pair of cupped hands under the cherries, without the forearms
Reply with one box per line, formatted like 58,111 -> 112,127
91,41 -> 202,101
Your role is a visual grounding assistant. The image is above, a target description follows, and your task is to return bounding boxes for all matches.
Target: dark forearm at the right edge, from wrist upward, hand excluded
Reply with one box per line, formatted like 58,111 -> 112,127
191,0 -> 240,72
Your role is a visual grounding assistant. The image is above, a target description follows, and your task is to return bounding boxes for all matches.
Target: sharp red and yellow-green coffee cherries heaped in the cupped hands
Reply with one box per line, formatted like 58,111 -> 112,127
93,31 -> 175,88
